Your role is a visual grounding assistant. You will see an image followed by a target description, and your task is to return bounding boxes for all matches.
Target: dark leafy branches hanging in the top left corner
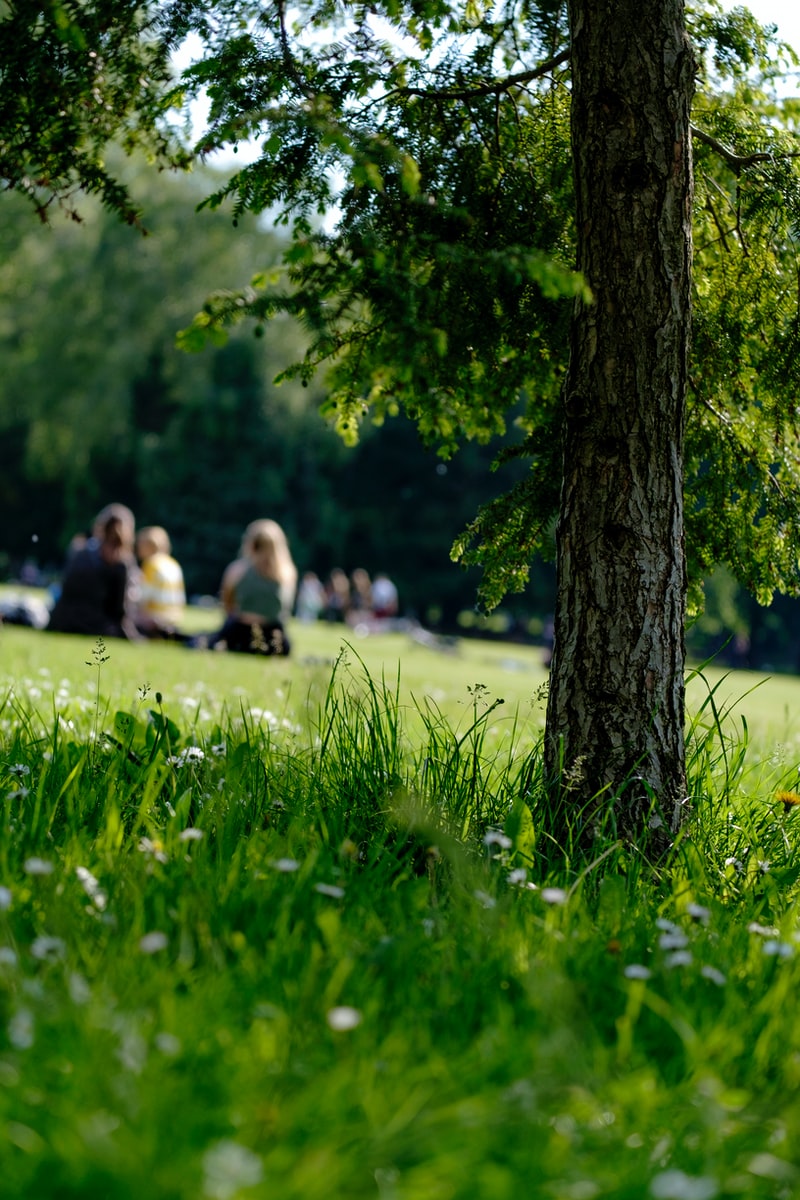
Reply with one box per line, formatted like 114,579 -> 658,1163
0,0 -> 188,224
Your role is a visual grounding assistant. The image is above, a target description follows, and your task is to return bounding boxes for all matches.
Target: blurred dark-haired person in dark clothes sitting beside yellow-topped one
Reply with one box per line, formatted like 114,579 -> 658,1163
47,504 -> 139,640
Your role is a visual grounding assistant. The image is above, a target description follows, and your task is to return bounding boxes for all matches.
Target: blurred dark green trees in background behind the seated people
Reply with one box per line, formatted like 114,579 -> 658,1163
0,161 -> 553,631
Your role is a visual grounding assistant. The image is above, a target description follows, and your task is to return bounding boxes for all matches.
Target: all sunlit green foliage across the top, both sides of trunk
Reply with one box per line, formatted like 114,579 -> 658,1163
6,0 -> 800,605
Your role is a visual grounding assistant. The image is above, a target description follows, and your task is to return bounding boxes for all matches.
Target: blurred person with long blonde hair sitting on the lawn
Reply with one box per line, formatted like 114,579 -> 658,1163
209,520 -> 297,654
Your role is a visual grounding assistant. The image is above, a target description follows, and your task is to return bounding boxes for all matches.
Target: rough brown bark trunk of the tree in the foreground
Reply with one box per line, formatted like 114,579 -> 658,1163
546,0 -> 694,842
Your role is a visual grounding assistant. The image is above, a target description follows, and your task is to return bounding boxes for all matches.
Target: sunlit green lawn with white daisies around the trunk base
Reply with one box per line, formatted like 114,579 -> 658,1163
0,625 -> 800,1200
